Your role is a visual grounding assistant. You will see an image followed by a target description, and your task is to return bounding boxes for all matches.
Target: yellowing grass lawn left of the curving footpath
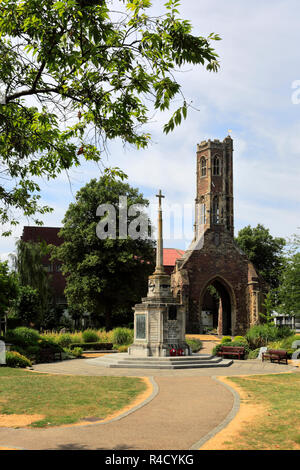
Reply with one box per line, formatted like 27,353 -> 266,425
0,367 -> 146,427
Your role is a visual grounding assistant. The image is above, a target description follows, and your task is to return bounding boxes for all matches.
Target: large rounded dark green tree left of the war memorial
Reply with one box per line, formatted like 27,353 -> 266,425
52,177 -> 155,329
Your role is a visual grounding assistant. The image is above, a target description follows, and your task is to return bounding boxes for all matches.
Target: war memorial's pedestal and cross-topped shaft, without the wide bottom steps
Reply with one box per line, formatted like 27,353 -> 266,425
128,191 -> 190,357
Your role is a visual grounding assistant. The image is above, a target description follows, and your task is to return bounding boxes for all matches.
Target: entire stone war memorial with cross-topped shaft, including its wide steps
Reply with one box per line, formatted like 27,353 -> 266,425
102,185 -> 233,369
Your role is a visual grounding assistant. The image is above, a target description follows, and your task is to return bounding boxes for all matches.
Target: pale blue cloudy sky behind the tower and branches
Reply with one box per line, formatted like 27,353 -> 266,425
0,0 -> 300,260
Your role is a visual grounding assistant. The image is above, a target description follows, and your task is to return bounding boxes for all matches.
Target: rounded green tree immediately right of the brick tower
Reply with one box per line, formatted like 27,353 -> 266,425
235,224 -> 286,289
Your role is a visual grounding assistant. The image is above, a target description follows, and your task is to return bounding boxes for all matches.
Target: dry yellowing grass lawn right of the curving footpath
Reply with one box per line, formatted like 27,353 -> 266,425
226,373 -> 300,450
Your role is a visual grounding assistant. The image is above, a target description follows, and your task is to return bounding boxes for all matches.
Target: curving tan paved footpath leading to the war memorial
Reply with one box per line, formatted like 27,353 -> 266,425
0,359 -> 299,450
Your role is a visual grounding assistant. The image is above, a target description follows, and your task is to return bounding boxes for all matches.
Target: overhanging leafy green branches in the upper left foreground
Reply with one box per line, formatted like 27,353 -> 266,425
0,0 -> 220,234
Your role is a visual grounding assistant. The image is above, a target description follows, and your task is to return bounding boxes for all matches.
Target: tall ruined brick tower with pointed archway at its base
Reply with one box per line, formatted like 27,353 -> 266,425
171,136 -> 262,335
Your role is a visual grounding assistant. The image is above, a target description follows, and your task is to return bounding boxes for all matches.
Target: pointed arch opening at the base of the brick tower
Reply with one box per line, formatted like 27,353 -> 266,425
199,276 -> 236,336
